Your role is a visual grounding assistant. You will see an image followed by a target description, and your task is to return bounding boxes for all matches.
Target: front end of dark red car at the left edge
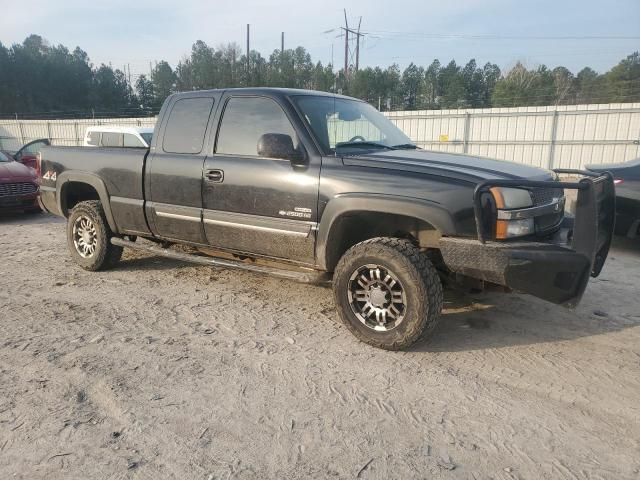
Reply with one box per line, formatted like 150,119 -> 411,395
0,152 -> 40,212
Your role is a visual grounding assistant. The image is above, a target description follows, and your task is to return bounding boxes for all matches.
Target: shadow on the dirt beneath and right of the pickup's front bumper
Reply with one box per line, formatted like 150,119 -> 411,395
411,237 -> 640,352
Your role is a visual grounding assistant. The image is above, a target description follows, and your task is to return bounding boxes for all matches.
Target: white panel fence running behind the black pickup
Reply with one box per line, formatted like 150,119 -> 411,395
0,103 -> 640,168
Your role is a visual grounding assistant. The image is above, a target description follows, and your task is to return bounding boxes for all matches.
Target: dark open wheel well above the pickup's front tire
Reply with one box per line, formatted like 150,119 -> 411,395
326,212 -> 440,271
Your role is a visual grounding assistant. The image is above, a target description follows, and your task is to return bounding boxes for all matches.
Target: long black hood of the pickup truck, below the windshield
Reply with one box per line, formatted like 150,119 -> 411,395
343,150 -> 555,183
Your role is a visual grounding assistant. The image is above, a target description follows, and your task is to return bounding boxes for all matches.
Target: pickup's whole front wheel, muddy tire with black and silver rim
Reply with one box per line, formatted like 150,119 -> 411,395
333,237 -> 443,350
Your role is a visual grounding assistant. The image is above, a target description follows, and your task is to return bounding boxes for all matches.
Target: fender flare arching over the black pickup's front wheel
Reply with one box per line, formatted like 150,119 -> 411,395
316,193 -> 456,269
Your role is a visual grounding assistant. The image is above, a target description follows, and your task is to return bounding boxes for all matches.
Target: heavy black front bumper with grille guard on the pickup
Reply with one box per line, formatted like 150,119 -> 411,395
440,170 -> 615,307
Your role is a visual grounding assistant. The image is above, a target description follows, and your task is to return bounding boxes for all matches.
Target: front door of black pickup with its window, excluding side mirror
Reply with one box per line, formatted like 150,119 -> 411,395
202,94 -> 320,264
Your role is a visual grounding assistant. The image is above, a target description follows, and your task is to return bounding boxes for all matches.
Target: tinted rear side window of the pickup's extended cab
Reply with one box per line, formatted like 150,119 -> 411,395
162,98 -> 213,153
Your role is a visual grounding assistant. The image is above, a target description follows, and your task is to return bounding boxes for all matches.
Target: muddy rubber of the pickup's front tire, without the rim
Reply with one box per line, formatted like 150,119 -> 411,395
334,237 -> 443,350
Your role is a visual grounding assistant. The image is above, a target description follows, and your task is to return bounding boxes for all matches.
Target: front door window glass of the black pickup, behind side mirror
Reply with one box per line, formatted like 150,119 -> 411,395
216,97 -> 298,155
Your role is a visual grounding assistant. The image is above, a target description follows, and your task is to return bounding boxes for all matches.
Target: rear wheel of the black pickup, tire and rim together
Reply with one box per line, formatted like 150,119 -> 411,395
67,200 -> 122,271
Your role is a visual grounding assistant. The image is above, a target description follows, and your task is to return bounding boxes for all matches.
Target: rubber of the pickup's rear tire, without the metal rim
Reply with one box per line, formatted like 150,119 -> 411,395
67,200 -> 123,272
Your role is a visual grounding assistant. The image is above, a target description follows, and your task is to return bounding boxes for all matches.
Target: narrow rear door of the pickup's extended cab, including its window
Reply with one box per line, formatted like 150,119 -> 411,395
145,95 -> 216,244
